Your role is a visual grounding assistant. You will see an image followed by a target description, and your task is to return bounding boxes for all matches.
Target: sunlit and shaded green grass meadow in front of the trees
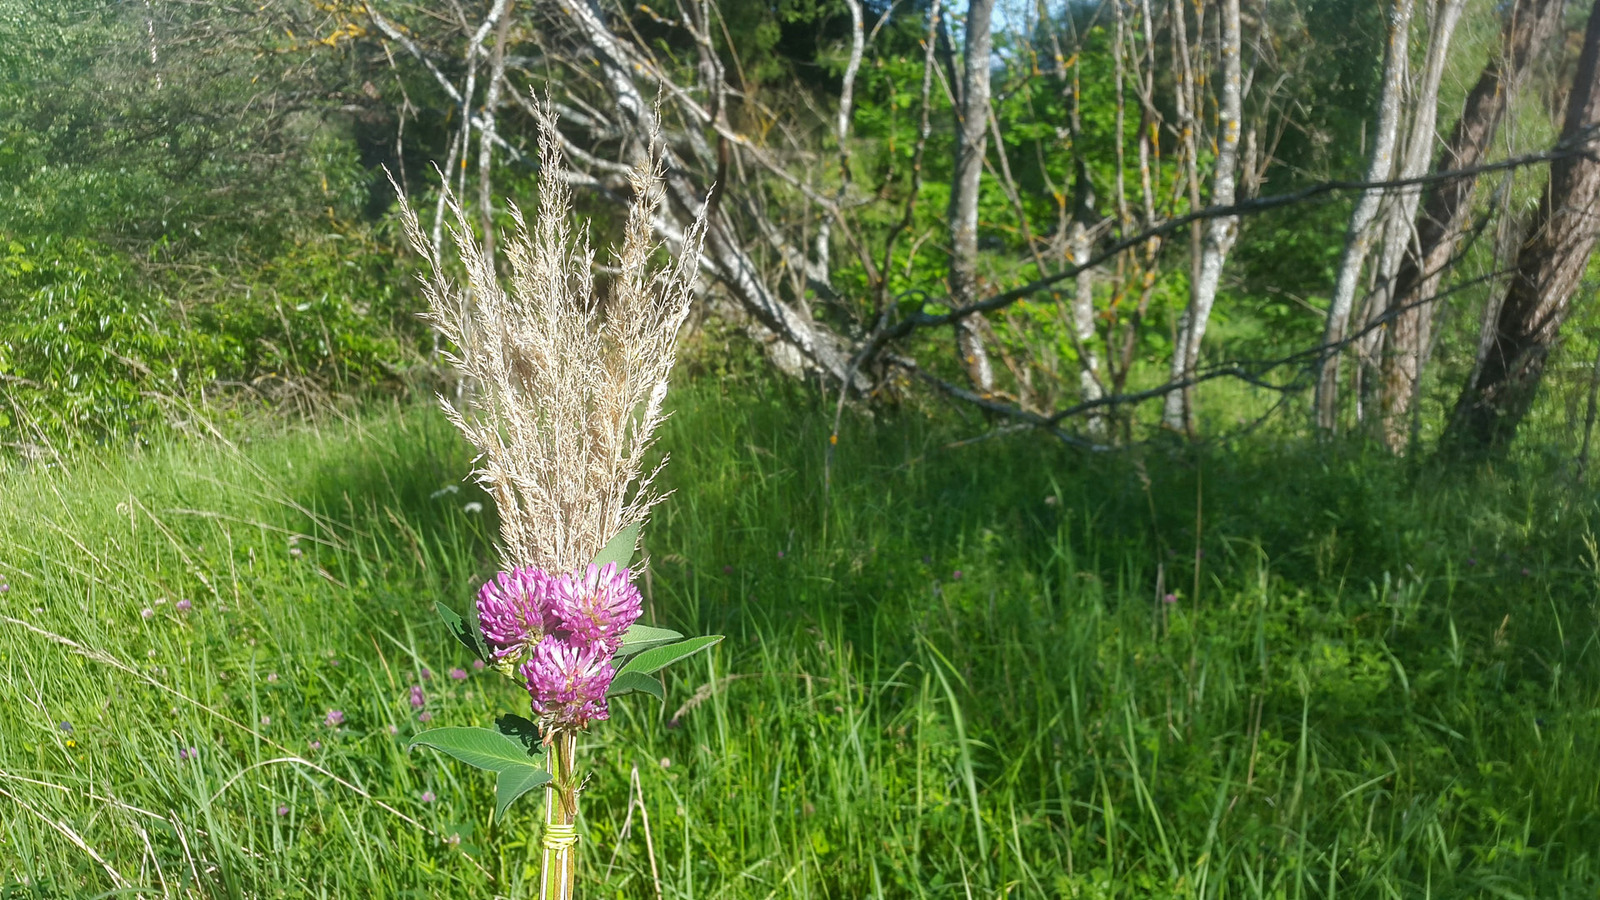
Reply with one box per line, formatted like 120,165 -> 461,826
0,374 -> 1600,898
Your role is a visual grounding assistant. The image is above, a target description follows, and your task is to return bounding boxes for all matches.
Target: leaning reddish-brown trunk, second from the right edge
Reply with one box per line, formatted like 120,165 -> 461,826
1379,0 -> 1565,453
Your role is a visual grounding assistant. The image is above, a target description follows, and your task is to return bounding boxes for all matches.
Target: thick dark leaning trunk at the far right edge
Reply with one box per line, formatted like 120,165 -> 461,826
1445,0 -> 1600,455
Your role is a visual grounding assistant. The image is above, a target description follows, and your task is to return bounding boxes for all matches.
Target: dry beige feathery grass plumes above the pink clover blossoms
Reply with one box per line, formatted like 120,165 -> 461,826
400,107 -> 704,572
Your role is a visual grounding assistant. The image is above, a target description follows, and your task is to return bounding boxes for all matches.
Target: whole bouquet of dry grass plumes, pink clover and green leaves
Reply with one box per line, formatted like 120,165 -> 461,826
402,112 -> 722,900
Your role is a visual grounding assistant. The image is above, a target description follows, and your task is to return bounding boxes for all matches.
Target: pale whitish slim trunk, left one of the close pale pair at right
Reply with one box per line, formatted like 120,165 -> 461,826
1314,0 -> 1413,431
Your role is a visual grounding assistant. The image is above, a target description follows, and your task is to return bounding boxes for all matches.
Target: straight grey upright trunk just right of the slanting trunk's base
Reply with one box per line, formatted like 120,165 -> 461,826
950,0 -> 995,394
